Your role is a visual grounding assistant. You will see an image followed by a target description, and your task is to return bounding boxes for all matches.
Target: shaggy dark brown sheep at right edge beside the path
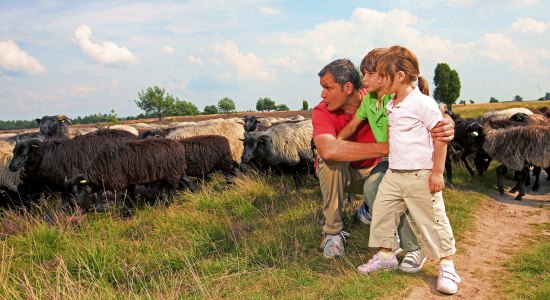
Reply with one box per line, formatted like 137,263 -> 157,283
483,125 -> 550,200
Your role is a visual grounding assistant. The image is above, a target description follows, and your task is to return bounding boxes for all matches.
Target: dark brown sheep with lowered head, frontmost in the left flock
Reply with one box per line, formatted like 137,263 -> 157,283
65,138 -> 187,217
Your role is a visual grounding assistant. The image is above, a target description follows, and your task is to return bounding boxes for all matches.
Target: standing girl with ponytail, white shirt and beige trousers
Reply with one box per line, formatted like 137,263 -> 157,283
357,46 -> 461,294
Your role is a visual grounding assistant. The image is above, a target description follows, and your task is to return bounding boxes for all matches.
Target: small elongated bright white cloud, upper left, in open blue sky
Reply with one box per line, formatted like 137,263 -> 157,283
73,24 -> 139,65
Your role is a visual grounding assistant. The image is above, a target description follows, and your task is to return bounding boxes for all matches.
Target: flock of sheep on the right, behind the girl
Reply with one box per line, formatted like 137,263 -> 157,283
445,107 -> 550,200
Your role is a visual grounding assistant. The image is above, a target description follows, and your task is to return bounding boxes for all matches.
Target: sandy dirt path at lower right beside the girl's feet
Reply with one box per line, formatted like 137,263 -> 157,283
408,174 -> 550,299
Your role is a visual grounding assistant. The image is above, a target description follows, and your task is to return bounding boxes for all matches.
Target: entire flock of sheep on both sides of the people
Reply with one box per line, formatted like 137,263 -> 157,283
0,107 -> 550,216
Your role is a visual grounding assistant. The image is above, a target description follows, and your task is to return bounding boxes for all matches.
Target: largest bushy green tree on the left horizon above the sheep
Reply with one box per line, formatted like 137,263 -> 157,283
134,85 -> 174,121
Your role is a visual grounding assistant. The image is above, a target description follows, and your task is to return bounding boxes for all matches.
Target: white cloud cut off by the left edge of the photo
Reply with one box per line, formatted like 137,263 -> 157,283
0,39 -> 46,75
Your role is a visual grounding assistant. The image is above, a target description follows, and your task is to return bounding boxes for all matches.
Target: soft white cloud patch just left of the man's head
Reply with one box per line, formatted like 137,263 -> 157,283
214,41 -> 273,81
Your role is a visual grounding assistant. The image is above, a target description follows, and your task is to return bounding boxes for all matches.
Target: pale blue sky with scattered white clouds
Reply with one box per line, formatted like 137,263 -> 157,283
0,0 -> 550,120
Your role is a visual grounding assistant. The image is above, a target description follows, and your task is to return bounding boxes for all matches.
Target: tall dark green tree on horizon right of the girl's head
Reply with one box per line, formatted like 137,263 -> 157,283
434,63 -> 461,111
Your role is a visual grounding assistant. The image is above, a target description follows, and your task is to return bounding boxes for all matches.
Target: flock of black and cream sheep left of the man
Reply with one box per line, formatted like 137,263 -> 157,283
0,115 -> 313,216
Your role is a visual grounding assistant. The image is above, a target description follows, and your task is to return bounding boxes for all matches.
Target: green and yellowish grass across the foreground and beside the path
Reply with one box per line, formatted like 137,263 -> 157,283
0,102 -> 550,299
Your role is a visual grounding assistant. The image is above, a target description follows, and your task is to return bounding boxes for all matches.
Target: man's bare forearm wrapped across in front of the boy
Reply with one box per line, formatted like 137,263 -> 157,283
313,134 -> 390,162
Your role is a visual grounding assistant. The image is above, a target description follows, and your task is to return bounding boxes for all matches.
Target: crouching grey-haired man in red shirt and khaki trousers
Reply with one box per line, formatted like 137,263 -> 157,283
312,59 -> 454,258
